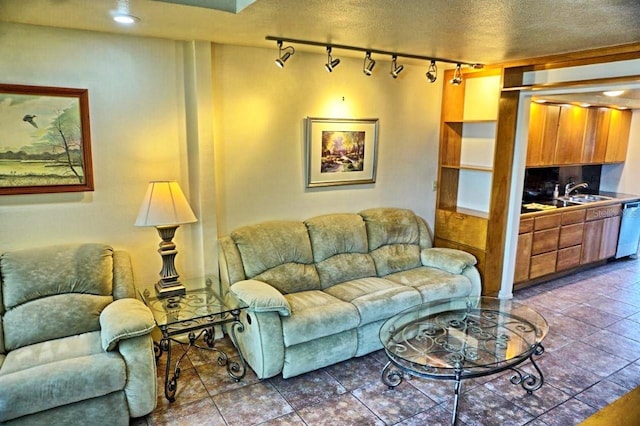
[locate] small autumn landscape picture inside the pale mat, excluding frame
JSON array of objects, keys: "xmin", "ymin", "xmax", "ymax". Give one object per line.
[{"xmin": 320, "ymin": 131, "xmax": 365, "ymax": 173}]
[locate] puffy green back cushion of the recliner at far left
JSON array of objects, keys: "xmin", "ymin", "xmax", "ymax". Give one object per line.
[{"xmin": 0, "ymin": 244, "xmax": 113, "ymax": 351}]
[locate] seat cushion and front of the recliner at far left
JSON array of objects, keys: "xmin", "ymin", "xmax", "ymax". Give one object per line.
[{"xmin": 0, "ymin": 332, "xmax": 127, "ymax": 422}]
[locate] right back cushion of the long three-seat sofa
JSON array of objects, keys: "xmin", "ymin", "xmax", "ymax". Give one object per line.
[{"xmin": 360, "ymin": 208, "xmax": 428, "ymax": 277}]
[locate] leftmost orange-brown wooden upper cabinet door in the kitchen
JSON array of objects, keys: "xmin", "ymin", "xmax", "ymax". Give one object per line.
[{"xmin": 527, "ymin": 102, "xmax": 560, "ymax": 167}]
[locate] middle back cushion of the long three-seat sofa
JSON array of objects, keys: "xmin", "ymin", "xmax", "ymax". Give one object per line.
[{"xmin": 305, "ymin": 214, "xmax": 376, "ymax": 289}]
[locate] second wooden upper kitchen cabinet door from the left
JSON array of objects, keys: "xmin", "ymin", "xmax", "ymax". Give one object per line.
[{"xmin": 554, "ymin": 106, "xmax": 588, "ymax": 164}]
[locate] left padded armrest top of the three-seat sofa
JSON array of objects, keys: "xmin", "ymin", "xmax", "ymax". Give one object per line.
[{"xmin": 229, "ymin": 280, "xmax": 291, "ymax": 317}]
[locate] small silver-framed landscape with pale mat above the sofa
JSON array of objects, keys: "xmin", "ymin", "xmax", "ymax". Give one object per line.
[{"xmin": 306, "ymin": 117, "xmax": 378, "ymax": 188}]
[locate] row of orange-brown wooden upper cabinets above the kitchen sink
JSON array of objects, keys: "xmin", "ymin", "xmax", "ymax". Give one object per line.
[{"xmin": 527, "ymin": 102, "xmax": 631, "ymax": 167}]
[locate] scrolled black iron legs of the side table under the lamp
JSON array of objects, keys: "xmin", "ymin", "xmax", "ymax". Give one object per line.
[{"xmin": 154, "ymin": 321, "xmax": 247, "ymax": 402}]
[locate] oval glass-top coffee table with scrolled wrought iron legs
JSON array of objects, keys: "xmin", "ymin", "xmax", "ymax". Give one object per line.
[{"xmin": 380, "ymin": 297, "xmax": 549, "ymax": 424}]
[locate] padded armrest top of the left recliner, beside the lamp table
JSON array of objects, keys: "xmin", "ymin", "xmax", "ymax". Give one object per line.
[{"xmin": 100, "ymin": 298, "xmax": 156, "ymax": 351}]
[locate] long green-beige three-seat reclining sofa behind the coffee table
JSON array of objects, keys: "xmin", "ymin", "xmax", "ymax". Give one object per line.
[{"xmin": 219, "ymin": 208, "xmax": 481, "ymax": 379}]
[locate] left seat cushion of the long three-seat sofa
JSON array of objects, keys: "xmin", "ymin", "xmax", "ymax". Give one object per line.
[{"xmin": 282, "ymin": 290, "xmax": 360, "ymax": 347}]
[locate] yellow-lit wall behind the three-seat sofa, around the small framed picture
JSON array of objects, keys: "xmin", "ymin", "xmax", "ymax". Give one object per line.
[{"xmin": 214, "ymin": 43, "xmax": 442, "ymax": 234}]
